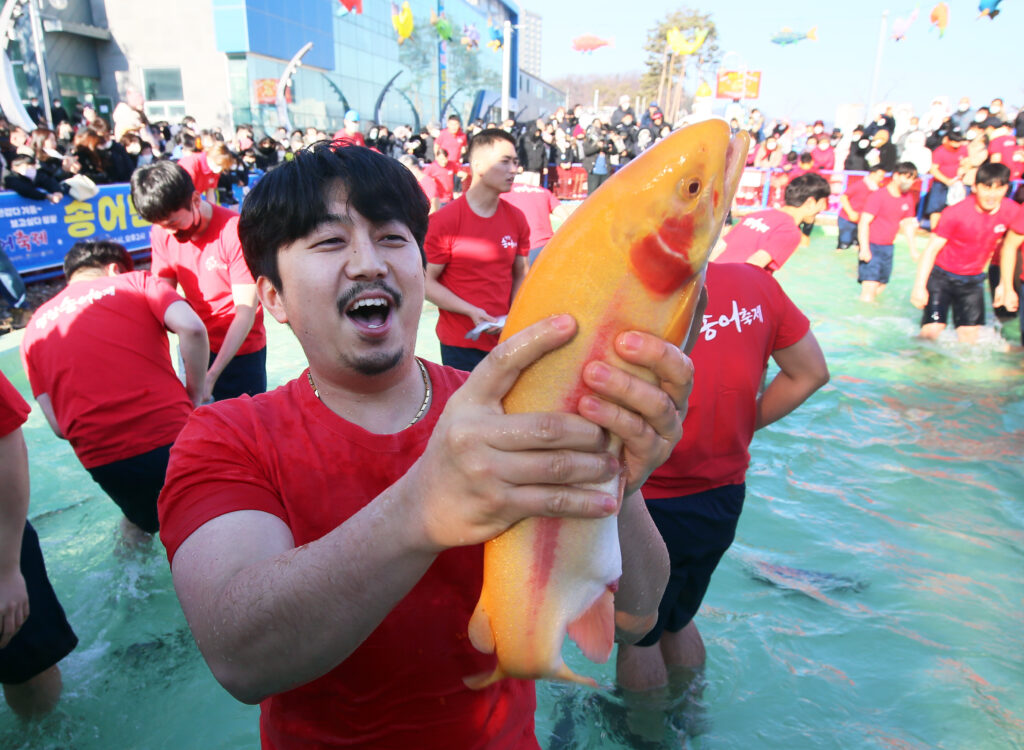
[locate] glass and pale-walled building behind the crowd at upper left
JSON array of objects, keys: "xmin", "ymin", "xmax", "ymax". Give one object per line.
[{"xmin": 11, "ymin": 0, "xmax": 519, "ymax": 131}]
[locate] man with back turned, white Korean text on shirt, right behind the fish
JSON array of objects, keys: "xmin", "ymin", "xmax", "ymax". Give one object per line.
[{"xmin": 616, "ymin": 262, "xmax": 828, "ymax": 691}]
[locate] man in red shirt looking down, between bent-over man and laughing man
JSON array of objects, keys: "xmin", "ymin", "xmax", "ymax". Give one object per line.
[{"xmin": 131, "ymin": 161, "xmax": 266, "ymax": 402}]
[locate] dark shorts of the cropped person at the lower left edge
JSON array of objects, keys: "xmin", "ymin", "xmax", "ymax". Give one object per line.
[{"xmin": 0, "ymin": 522, "xmax": 78, "ymax": 684}]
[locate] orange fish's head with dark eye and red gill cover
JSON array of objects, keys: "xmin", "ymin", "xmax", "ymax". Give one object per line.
[{"xmin": 614, "ymin": 120, "xmax": 750, "ymax": 295}]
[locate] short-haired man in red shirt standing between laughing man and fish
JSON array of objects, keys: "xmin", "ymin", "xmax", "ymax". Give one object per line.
[{"xmin": 424, "ymin": 128, "xmax": 529, "ymax": 371}]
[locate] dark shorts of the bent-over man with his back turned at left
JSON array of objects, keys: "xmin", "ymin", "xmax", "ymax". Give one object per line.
[{"xmin": 86, "ymin": 443, "xmax": 173, "ymax": 534}]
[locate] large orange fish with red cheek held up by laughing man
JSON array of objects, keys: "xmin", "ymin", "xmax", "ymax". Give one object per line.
[{"xmin": 466, "ymin": 120, "xmax": 750, "ymax": 688}]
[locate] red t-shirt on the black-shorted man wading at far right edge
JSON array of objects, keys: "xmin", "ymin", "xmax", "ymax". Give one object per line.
[{"xmin": 935, "ymin": 196, "xmax": 1018, "ymax": 276}]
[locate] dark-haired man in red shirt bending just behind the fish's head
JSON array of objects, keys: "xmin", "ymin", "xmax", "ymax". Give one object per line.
[{"xmin": 711, "ymin": 173, "xmax": 831, "ymax": 274}]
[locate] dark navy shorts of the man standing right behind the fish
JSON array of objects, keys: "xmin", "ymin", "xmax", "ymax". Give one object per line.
[{"xmin": 637, "ymin": 485, "xmax": 746, "ymax": 645}]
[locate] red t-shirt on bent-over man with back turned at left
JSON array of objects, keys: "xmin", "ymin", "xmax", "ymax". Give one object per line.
[{"xmin": 22, "ymin": 270, "xmax": 193, "ymax": 468}]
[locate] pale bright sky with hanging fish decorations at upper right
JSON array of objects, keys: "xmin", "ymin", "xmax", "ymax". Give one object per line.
[{"xmin": 520, "ymin": 0, "xmax": 1024, "ymax": 122}]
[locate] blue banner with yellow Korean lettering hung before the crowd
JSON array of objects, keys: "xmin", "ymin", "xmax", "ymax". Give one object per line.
[{"xmin": 0, "ymin": 182, "xmax": 150, "ymax": 275}]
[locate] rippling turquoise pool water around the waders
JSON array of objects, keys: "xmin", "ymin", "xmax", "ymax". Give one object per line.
[{"xmin": 0, "ymin": 230, "xmax": 1024, "ymax": 750}]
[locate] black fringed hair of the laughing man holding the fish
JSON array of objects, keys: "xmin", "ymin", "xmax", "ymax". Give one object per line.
[{"xmin": 239, "ymin": 140, "xmax": 430, "ymax": 291}]
